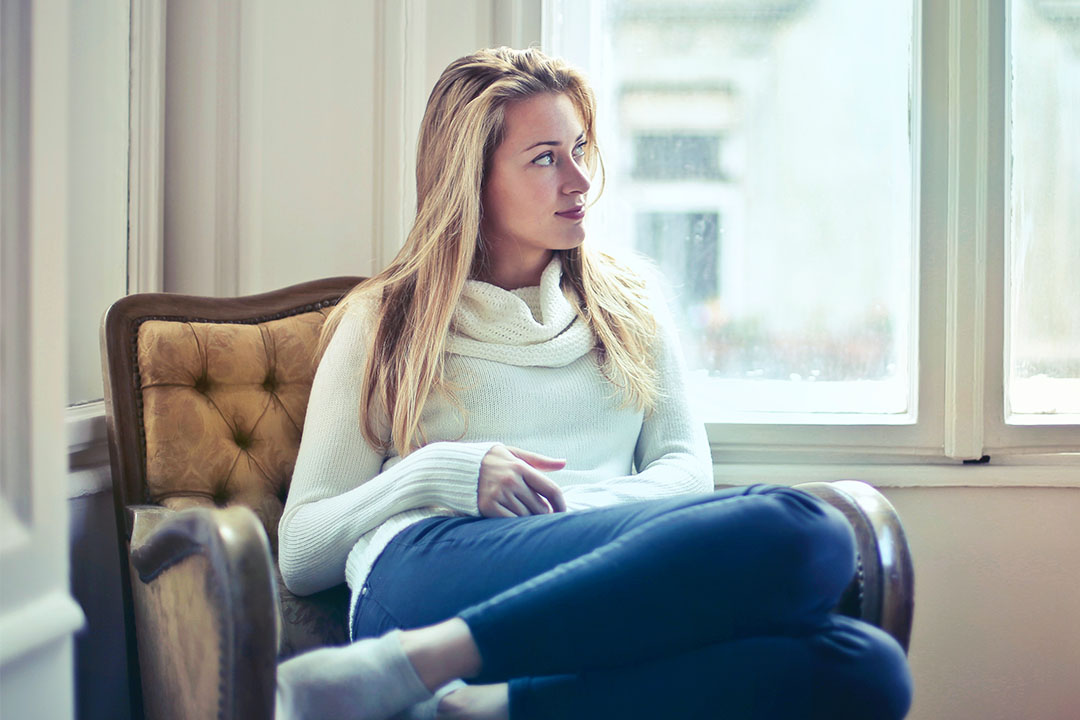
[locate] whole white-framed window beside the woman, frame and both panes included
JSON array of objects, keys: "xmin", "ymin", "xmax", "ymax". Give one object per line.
[{"xmin": 543, "ymin": 0, "xmax": 1080, "ymax": 460}]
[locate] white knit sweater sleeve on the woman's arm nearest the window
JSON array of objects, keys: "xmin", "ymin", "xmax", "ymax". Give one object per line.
[{"xmin": 564, "ymin": 278, "xmax": 713, "ymax": 511}]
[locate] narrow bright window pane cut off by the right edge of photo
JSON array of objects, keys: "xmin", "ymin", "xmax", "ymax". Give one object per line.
[{"xmin": 1007, "ymin": 0, "xmax": 1080, "ymax": 423}]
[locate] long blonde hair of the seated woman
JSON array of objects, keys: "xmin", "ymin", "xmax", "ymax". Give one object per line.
[{"xmin": 320, "ymin": 47, "xmax": 657, "ymax": 456}]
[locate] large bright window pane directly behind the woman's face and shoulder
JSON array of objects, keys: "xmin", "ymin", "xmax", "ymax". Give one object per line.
[{"xmin": 578, "ymin": 0, "xmax": 916, "ymax": 423}]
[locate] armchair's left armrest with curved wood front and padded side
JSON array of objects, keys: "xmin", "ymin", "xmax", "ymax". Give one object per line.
[{"xmin": 130, "ymin": 506, "xmax": 278, "ymax": 720}]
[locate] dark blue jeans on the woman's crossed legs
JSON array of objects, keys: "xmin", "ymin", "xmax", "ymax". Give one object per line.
[{"xmin": 353, "ymin": 486, "xmax": 912, "ymax": 720}]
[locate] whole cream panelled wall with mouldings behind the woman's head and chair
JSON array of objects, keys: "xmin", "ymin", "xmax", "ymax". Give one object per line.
[{"xmin": 164, "ymin": 0, "xmax": 524, "ymax": 295}]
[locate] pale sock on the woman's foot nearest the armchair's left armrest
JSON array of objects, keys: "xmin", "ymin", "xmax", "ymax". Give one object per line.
[{"xmin": 274, "ymin": 630, "xmax": 437, "ymax": 720}]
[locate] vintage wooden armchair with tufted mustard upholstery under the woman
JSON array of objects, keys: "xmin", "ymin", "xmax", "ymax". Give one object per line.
[{"xmin": 102, "ymin": 277, "xmax": 913, "ymax": 720}]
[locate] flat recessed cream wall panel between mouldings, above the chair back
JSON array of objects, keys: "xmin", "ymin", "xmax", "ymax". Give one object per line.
[{"xmin": 238, "ymin": 2, "xmax": 379, "ymax": 293}]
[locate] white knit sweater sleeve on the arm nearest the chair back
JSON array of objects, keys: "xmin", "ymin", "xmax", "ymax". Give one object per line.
[{"xmin": 278, "ymin": 313, "xmax": 492, "ymax": 595}]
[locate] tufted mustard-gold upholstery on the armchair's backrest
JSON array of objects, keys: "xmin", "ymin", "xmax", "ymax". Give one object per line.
[{"xmin": 137, "ymin": 310, "xmax": 327, "ymax": 551}]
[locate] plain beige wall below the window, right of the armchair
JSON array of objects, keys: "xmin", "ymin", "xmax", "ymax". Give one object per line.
[{"xmin": 886, "ymin": 487, "xmax": 1080, "ymax": 720}]
